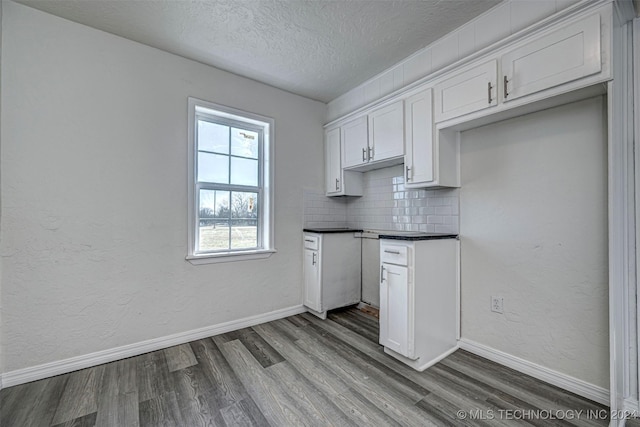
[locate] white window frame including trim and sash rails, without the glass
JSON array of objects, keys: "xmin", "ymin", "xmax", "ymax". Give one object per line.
[{"xmin": 186, "ymin": 97, "xmax": 276, "ymax": 265}]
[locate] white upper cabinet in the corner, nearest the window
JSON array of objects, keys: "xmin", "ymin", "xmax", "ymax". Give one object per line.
[{"xmin": 324, "ymin": 128, "xmax": 363, "ymax": 196}]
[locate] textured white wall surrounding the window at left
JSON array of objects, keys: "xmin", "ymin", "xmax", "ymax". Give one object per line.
[{"xmin": 0, "ymin": 2, "xmax": 326, "ymax": 372}]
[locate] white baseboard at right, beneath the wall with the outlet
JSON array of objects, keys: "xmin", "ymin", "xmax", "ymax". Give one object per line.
[{"xmin": 458, "ymin": 338, "xmax": 610, "ymax": 406}]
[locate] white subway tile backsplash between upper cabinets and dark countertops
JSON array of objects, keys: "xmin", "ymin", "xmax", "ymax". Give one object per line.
[{"xmin": 304, "ymin": 165, "xmax": 459, "ymax": 233}]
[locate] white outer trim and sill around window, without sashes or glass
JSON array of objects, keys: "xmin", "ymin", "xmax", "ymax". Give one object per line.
[{"xmin": 185, "ymin": 97, "xmax": 277, "ymax": 265}]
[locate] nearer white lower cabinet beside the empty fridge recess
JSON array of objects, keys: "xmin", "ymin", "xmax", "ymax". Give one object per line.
[{"xmin": 380, "ymin": 238, "xmax": 459, "ymax": 371}]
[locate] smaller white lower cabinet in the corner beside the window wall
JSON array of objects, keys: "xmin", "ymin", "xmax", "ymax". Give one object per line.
[{"xmin": 303, "ymin": 232, "xmax": 361, "ymax": 319}]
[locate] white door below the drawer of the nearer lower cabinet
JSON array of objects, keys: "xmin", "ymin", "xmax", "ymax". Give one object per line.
[{"xmin": 380, "ymin": 263, "xmax": 413, "ymax": 358}]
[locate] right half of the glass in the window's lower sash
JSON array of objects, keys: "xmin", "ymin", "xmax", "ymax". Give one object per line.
[{"xmin": 231, "ymin": 191, "xmax": 258, "ymax": 249}]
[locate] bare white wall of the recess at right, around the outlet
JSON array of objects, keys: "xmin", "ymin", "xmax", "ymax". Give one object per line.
[{"xmin": 460, "ymin": 98, "xmax": 609, "ymax": 389}]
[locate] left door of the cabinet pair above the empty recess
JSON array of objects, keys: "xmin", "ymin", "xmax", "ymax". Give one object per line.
[{"xmin": 434, "ymin": 60, "xmax": 498, "ymax": 123}]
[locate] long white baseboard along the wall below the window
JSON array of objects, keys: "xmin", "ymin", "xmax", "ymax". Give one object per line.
[{"xmin": 0, "ymin": 305, "xmax": 307, "ymax": 388}]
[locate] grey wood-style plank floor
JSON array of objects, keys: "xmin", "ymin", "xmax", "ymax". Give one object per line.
[{"xmin": 0, "ymin": 308, "xmax": 608, "ymax": 427}]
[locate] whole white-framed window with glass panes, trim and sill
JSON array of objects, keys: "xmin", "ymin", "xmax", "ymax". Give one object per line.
[{"xmin": 187, "ymin": 98, "xmax": 275, "ymax": 263}]
